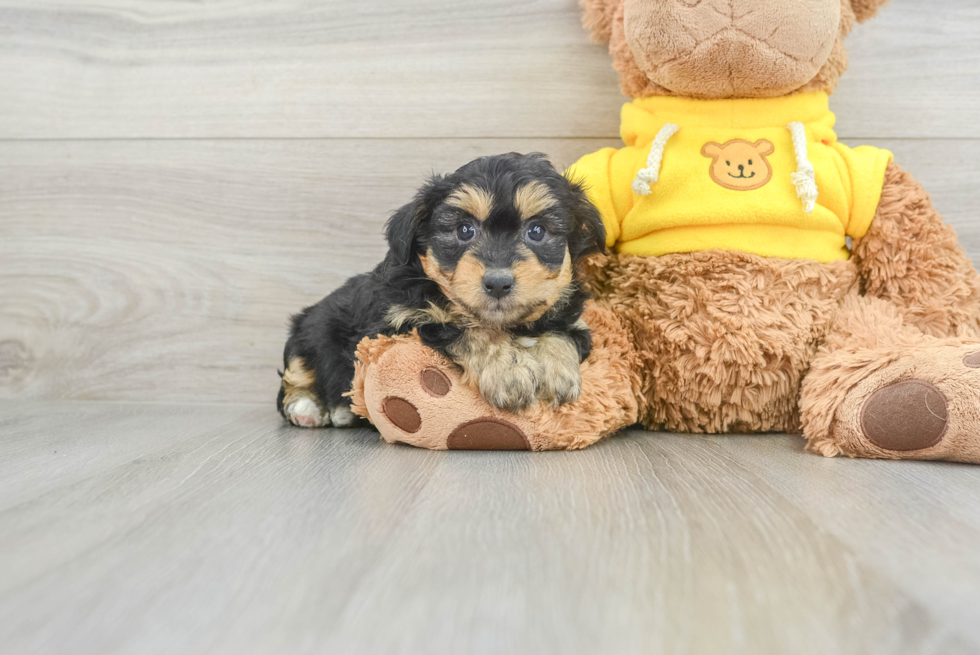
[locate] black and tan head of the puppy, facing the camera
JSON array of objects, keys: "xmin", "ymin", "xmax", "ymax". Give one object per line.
[{"xmin": 408, "ymin": 155, "xmax": 605, "ymax": 327}]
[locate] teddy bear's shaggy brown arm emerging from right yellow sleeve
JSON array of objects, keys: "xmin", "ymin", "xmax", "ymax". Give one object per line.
[{"xmin": 853, "ymin": 163, "xmax": 980, "ymax": 336}]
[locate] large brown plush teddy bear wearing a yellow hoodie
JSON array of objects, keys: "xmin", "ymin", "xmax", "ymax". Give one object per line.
[{"xmin": 351, "ymin": 0, "xmax": 980, "ymax": 463}]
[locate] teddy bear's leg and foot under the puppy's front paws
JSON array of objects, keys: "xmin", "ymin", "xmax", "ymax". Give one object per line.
[{"xmin": 351, "ymin": 304, "xmax": 639, "ymax": 450}]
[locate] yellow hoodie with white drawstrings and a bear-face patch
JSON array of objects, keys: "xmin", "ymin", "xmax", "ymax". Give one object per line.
[{"xmin": 566, "ymin": 93, "xmax": 892, "ymax": 262}]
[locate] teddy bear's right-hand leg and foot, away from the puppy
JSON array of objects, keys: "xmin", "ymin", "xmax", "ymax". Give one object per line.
[{"xmin": 800, "ymin": 295, "xmax": 980, "ymax": 463}]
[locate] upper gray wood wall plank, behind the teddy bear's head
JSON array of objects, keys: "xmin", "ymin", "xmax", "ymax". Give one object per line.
[{"xmin": 0, "ymin": 0, "xmax": 980, "ymax": 139}]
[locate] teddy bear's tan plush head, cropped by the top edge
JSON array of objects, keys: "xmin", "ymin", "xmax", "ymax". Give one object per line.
[{"xmin": 581, "ymin": 0, "xmax": 888, "ymax": 99}]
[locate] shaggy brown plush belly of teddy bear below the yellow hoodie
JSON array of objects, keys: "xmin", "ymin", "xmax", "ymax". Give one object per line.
[{"xmin": 580, "ymin": 251, "xmax": 856, "ymax": 432}]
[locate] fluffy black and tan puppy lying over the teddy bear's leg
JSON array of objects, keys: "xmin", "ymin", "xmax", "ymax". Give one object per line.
[{"xmin": 278, "ymin": 153, "xmax": 605, "ymax": 427}]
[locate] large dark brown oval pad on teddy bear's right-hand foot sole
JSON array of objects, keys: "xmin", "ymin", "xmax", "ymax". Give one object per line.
[{"xmin": 861, "ymin": 380, "xmax": 948, "ymax": 451}]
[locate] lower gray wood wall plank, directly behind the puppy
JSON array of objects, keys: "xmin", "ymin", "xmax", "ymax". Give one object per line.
[{"xmin": 0, "ymin": 139, "xmax": 980, "ymax": 403}]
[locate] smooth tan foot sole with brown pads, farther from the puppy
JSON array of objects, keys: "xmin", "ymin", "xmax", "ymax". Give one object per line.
[{"xmin": 831, "ymin": 342, "xmax": 980, "ymax": 463}]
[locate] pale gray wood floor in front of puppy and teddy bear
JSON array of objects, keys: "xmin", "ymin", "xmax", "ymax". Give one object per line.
[{"xmin": 0, "ymin": 403, "xmax": 980, "ymax": 655}]
